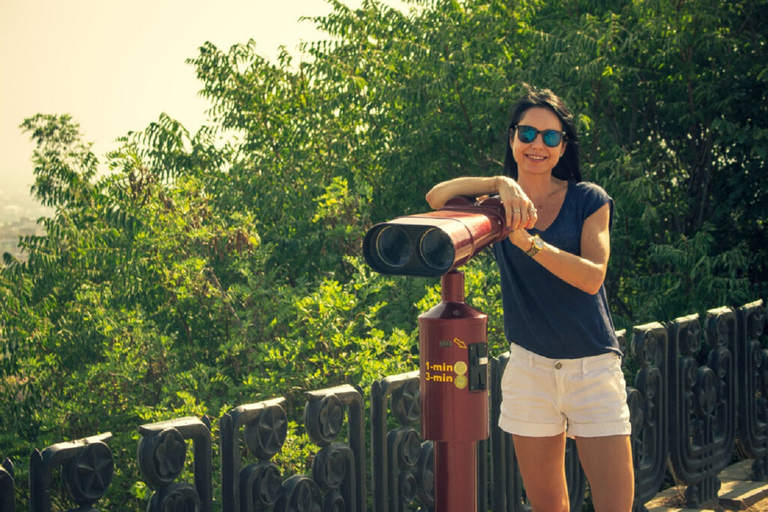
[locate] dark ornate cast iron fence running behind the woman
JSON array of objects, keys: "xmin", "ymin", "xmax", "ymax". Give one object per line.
[{"xmin": 0, "ymin": 301, "xmax": 768, "ymax": 512}]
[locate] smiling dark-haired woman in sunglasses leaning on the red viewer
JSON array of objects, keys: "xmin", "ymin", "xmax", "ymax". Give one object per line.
[{"xmin": 427, "ymin": 90, "xmax": 634, "ymax": 512}]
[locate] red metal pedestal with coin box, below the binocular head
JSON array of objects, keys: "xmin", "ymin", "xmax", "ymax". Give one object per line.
[{"xmin": 419, "ymin": 271, "xmax": 489, "ymax": 512}]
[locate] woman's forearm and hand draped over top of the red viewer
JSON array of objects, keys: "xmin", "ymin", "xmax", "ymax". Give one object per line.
[{"xmin": 427, "ymin": 176, "xmax": 538, "ymax": 229}]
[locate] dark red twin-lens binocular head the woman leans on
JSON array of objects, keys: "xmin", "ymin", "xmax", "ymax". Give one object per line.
[{"xmin": 363, "ymin": 196, "xmax": 507, "ymax": 277}]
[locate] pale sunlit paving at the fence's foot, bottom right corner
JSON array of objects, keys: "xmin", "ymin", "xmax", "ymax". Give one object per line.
[{"xmin": 646, "ymin": 460, "xmax": 768, "ymax": 512}]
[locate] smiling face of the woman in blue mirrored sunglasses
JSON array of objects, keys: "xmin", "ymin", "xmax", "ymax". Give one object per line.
[{"xmin": 510, "ymin": 107, "xmax": 566, "ymax": 177}]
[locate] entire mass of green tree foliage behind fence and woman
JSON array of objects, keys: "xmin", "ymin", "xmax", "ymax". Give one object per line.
[{"xmin": 0, "ymin": 0, "xmax": 768, "ymax": 510}]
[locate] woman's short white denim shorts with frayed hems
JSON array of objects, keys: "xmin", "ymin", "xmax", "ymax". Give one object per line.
[{"xmin": 499, "ymin": 344, "xmax": 632, "ymax": 437}]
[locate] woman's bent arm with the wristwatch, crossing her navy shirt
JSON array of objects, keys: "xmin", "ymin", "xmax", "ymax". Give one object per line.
[{"xmin": 509, "ymin": 204, "xmax": 611, "ymax": 295}]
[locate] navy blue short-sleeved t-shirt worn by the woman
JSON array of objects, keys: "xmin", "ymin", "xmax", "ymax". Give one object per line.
[{"xmin": 492, "ymin": 182, "xmax": 621, "ymax": 359}]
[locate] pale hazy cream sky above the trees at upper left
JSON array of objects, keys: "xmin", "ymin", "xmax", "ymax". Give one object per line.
[{"xmin": 0, "ymin": 0, "xmax": 390, "ymax": 189}]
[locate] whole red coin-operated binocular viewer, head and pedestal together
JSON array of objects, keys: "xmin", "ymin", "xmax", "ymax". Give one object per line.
[{"xmin": 363, "ymin": 197, "xmax": 508, "ymax": 512}]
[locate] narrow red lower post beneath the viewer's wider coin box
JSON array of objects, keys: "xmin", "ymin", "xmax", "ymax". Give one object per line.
[{"xmin": 434, "ymin": 441, "xmax": 477, "ymax": 512}]
